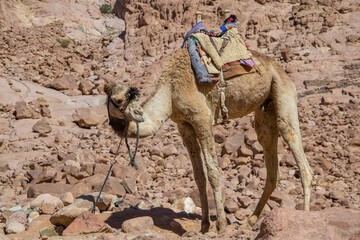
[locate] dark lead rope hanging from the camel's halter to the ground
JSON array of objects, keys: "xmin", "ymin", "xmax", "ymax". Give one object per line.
[{"xmin": 91, "ymin": 123, "xmax": 139, "ymax": 213}]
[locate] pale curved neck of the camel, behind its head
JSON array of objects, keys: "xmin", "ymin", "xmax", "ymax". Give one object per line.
[{"xmin": 128, "ymin": 82, "xmax": 172, "ymax": 137}]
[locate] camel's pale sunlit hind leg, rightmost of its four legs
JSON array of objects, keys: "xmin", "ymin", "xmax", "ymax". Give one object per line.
[{"xmin": 273, "ymin": 72, "xmax": 313, "ymax": 211}]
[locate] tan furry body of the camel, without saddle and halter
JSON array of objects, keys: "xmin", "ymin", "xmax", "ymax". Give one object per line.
[{"xmin": 105, "ymin": 50, "xmax": 313, "ymax": 233}]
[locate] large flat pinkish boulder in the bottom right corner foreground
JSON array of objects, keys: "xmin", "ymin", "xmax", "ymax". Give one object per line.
[{"xmin": 256, "ymin": 208, "xmax": 360, "ymax": 240}]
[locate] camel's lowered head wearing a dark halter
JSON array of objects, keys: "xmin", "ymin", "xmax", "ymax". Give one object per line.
[{"xmin": 104, "ymin": 84, "xmax": 144, "ymax": 127}]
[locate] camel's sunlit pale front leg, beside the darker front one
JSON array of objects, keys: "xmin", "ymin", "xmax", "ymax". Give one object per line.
[{"xmin": 194, "ymin": 117, "xmax": 227, "ymax": 233}]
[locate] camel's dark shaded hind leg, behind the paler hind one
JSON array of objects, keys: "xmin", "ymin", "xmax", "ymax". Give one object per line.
[{"xmin": 247, "ymin": 102, "xmax": 280, "ymax": 227}]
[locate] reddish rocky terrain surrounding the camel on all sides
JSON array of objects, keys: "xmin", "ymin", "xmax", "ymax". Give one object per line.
[{"xmin": 0, "ymin": 0, "xmax": 360, "ymax": 240}]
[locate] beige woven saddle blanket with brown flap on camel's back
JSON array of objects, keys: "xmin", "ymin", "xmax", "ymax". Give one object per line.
[{"xmin": 191, "ymin": 28, "xmax": 255, "ymax": 80}]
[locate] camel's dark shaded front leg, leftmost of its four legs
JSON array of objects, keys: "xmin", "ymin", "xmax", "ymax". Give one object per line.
[{"xmin": 178, "ymin": 122, "xmax": 210, "ymax": 233}]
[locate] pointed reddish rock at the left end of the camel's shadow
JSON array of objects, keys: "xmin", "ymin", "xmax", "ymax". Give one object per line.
[{"xmin": 62, "ymin": 212, "xmax": 114, "ymax": 236}]
